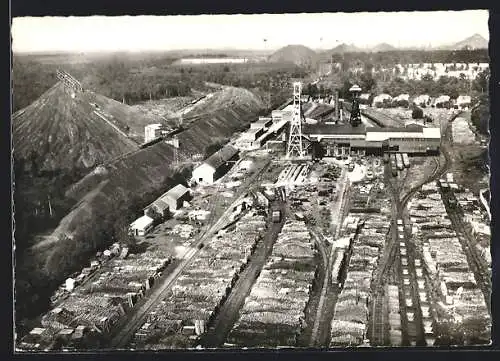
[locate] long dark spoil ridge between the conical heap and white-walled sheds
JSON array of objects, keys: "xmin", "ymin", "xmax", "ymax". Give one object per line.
[{"xmin": 35, "ymin": 88, "xmax": 263, "ymax": 252}]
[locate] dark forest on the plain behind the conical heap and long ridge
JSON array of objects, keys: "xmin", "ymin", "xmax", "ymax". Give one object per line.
[{"xmin": 13, "ymin": 55, "xmax": 307, "ymax": 112}]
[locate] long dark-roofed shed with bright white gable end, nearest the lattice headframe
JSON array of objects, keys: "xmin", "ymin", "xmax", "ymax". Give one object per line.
[{"xmin": 193, "ymin": 145, "xmax": 239, "ymax": 184}]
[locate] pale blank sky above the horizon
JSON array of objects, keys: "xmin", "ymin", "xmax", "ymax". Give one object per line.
[{"xmin": 12, "ymin": 10, "xmax": 489, "ymax": 52}]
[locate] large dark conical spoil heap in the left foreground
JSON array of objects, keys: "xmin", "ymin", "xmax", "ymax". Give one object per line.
[{"xmin": 12, "ymin": 82, "xmax": 141, "ymax": 169}]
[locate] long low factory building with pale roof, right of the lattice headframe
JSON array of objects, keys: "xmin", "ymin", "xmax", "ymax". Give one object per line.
[{"xmin": 303, "ymin": 123, "xmax": 441, "ymax": 157}]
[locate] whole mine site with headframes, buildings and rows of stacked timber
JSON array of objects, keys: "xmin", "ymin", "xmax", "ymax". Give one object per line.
[{"xmin": 19, "ymin": 76, "xmax": 491, "ymax": 350}]
